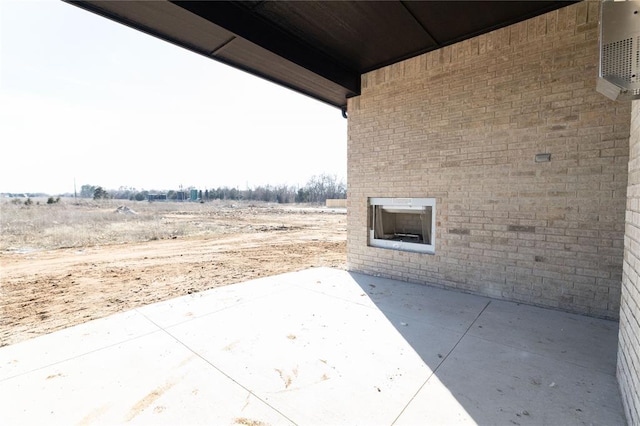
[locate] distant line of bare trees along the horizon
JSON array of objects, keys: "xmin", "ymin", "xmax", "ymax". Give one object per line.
[{"xmin": 80, "ymin": 174, "xmax": 347, "ymax": 203}]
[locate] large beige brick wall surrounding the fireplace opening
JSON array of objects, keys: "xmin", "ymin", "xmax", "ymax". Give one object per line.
[{"xmin": 347, "ymin": 2, "xmax": 630, "ymax": 318}]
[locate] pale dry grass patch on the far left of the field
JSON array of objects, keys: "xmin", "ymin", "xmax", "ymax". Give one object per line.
[{"xmin": 0, "ymin": 199, "xmax": 242, "ymax": 251}]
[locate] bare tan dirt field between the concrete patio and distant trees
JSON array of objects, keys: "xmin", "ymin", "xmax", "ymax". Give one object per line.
[{"xmin": 0, "ymin": 203, "xmax": 346, "ymax": 346}]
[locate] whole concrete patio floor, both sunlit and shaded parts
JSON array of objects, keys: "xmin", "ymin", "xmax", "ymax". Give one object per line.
[{"xmin": 0, "ymin": 268, "xmax": 625, "ymax": 425}]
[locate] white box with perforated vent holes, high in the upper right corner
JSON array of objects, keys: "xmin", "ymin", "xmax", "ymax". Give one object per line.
[{"xmin": 596, "ymin": 0, "xmax": 640, "ymax": 100}]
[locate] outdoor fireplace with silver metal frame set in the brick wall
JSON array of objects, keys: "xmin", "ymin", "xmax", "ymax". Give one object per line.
[{"xmin": 368, "ymin": 198, "xmax": 436, "ymax": 254}]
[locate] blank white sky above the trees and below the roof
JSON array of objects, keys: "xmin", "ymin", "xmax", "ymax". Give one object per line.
[{"xmin": 0, "ymin": 0, "xmax": 347, "ymax": 194}]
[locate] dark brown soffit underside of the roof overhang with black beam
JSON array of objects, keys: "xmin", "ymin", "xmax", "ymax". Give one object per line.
[{"xmin": 69, "ymin": 0, "xmax": 575, "ymax": 107}]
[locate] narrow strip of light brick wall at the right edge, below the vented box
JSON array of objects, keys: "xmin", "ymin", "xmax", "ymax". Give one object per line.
[{"xmin": 618, "ymin": 101, "xmax": 640, "ymax": 425}]
